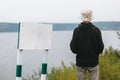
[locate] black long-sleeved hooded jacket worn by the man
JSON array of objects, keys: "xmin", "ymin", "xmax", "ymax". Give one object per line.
[{"xmin": 70, "ymin": 22, "xmax": 104, "ymax": 67}]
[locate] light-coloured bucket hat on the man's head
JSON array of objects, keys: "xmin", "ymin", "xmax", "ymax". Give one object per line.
[{"xmin": 81, "ymin": 10, "xmax": 93, "ymax": 22}]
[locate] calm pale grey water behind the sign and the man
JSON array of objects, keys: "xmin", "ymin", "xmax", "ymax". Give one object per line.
[{"xmin": 0, "ymin": 31, "xmax": 120, "ymax": 80}]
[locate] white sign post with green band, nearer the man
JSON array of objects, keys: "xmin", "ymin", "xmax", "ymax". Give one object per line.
[{"xmin": 41, "ymin": 49, "xmax": 48, "ymax": 80}]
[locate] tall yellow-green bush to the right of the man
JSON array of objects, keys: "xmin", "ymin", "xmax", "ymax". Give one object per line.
[{"xmin": 99, "ymin": 47, "xmax": 120, "ymax": 80}]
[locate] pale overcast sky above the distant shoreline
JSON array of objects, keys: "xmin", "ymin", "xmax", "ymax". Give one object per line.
[{"xmin": 0, "ymin": 0, "xmax": 120, "ymax": 23}]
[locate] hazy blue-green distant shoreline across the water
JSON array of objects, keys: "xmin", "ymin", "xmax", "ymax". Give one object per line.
[{"xmin": 0, "ymin": 21, "xmax": 120, "ymax": 32}]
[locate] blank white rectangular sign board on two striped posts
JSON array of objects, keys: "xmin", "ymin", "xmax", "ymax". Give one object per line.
[{"xmin": 18, "ymin": 22, "xmax": 52, "ymax": 50}]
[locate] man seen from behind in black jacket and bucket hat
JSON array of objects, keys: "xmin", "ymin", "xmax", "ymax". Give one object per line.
[{"xmin": 70, "ymin": 10, "xmax": 104, "ymax": 80}]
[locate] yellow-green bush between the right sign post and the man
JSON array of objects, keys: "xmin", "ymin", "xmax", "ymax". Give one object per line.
[{"xmin": 48, "ymin": 61, "xmax": 76, "ymax": 80}]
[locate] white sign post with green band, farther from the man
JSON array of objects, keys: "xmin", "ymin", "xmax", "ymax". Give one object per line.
[{"xmin": 16, "ymin": 49, "xmax": 23, "ymax": 80}]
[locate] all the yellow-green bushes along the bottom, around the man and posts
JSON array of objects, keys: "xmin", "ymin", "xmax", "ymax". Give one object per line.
[{"xmin": 23, "ymin": 47, "xmax": 120, "ymax": 80}]
